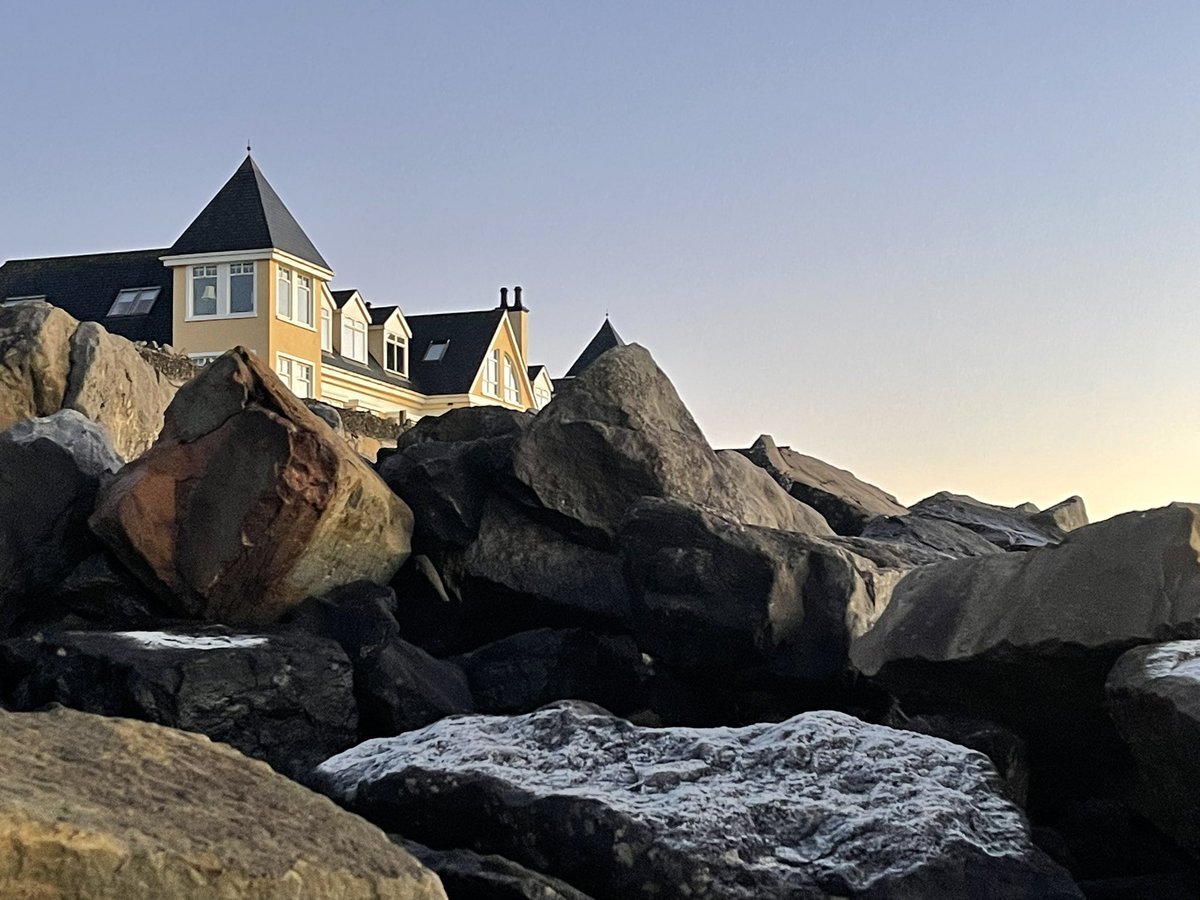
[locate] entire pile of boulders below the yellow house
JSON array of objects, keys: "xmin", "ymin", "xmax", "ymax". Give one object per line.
[{"xmin": 0, "ymin": 321, "xmax": 1200, "ymax": 900}]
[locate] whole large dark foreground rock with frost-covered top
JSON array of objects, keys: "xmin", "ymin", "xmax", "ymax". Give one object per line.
[{"xmin": 318, "ymin": 703, "xmax": 1079, "ymax": 900}]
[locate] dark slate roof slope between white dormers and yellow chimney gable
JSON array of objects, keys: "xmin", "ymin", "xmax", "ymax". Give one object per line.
[{"xmin": 404, "ymin": 308, "xmax": 504, "ymax": 394}]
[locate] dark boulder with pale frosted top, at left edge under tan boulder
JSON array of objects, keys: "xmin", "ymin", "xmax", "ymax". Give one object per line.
[{"xmin": 0, "ymin": 409, "xmax": 121, "ymax": 632}]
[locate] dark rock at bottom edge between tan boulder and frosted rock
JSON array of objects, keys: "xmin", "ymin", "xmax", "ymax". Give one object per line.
[{"xmin": 391, "ymin": 835, "xmax": 592, "ymax": 900}]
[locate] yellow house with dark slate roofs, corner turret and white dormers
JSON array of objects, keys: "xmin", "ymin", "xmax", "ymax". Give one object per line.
[{"xmin": 0, "ymin": 155, "xmax": 553, "ymax": 421}]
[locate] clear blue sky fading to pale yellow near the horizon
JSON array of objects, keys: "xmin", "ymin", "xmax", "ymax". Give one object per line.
[{"xmin": 0, "ymin": 0, "xmax": 1200, "ymax": 518}]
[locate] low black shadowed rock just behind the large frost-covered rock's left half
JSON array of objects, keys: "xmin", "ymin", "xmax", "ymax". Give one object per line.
[{"xmin": 455, "ymin": 628, "xmax": 649, "ymax": 715}]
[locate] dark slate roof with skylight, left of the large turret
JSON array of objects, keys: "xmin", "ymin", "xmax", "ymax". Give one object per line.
[{"xmin": 0, "ymin": 250, "xmax": 172, "ymax": 343}]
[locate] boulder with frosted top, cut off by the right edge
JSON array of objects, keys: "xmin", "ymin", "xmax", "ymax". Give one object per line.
[{"xmin": 1106, "ymin": 641, "xmax": 1200, "ymax": 856}]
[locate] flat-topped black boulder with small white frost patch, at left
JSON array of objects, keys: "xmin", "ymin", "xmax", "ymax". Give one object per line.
[{"xmin": 0, "ymin": 629, "xmax": 359, "ymax": 779}]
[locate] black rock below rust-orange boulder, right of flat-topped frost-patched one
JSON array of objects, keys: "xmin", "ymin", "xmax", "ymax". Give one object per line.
[{"xmin": 288, "ymin": 582, "xmax": 475, "ymax": 737}]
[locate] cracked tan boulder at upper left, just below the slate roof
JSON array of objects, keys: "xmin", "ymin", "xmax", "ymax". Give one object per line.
[{"xmin": 0, "ymin": 302, "xmax": 175, "ymax": 458}]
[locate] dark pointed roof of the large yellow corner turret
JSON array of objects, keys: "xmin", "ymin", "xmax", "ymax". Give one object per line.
[{"xmin": 168, "ymin": 155, "xmax": 330, "ymax": 269}]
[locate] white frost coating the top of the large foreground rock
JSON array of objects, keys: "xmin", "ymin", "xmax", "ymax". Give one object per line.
[{"xmin": 319, "ymin": 706, "xmax": 1033, "ymax": 896}]
